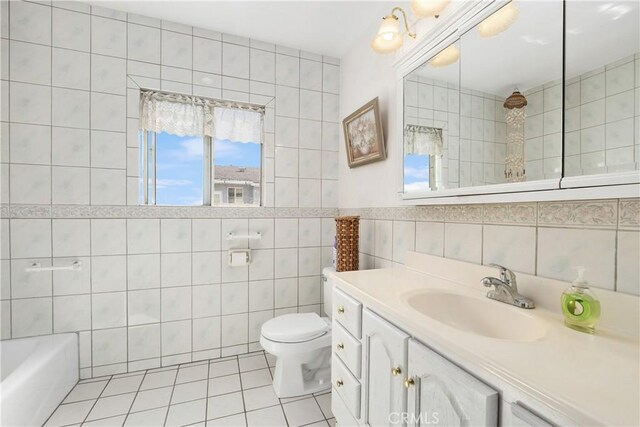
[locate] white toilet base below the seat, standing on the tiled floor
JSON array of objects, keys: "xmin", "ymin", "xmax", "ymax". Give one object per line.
[{"xmin": 273, "ymin": 347, "xmax": 331, "ymax": 399}]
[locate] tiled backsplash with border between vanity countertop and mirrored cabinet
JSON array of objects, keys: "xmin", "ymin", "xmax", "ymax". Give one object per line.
[{"xmin": 352, "ymin": 199, "xmax": 640, "ymax": 295}]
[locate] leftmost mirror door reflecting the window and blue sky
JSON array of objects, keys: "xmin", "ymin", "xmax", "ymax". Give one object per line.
[{"xmin": 403, "ymin": 43, "xmax": 460, "ymax": 193}]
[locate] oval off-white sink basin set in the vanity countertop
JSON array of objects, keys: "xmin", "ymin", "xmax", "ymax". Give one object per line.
[{"xmin": 406, "ymin": 291, "xmax": 546, "ymax": 341}]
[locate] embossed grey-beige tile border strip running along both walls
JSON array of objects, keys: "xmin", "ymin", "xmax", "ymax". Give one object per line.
[{"xmin": 6, "ymin": 198, "xmax": 640, "ymax": 229}]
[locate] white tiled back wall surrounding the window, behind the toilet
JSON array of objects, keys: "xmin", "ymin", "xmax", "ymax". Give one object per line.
[{"xmin": 0, "ymin": 1, "xmax": 339, "ymax": 377}]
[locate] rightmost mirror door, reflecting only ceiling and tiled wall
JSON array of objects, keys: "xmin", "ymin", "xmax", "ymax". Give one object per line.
[{"xmin": 565, "ymin": 0, "xmax": 640, "ymax": 176}]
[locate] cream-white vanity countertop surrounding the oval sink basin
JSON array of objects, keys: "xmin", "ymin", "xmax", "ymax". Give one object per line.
[{"xmin": 335, "ymin": 267, "xmax": 640, "ymax": 426}]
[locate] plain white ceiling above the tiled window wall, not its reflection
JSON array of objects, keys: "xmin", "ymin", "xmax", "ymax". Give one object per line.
[{"xmin": 90, "ymin": 0, "xmax": 402, "ymax": 58}]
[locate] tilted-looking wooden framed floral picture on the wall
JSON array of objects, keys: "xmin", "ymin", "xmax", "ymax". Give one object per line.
[{"xmin": 342, "ymin": 98, "xmax": 387, "ymax": 168}]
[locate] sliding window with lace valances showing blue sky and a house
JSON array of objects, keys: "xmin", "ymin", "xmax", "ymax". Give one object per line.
[{"xmin": 140, "ymin": 91, "xmax": 264, "ymax": 206}]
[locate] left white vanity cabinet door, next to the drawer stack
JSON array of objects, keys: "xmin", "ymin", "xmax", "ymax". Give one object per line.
[{"xmin": 362, "ymin": 310, "xmax": 409, "ymax": 426}]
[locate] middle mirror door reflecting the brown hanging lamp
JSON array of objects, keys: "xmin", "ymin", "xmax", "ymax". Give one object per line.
[{"xmin": 460, "ymin": 0, "xmax": 564, "ymax": 187}]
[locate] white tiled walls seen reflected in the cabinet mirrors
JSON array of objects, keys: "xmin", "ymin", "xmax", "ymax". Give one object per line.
[{"xmin": 405, "ymin": 54, "xmax": 640, "ymax": 187}]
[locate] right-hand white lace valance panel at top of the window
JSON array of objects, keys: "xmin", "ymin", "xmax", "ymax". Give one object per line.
[{"xmin": 214, "ymin": 107, "xmax": 264, "ymax": 144}]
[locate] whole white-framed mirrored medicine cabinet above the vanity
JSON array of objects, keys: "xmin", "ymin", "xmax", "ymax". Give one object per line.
[{"xmin": 398, "ymin": 0, "xmax": 640, "ymax": 201}]
